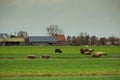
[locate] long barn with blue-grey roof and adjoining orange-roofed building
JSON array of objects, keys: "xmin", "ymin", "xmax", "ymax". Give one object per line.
[{"xmin": 28, "ymin": 35, "xmax": 66, "ymax": 45}]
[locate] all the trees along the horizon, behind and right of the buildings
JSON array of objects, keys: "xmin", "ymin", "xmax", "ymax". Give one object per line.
[{"xmin": 11, "ymin": 25, "xmax": 120, "ymax": 46}]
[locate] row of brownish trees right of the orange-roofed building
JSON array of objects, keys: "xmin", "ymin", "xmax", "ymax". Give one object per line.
[{"xmin": 67, "ymin": 32, "xmax": 120, "ymax": 46}]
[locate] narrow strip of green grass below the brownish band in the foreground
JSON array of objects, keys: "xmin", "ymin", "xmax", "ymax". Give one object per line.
[{"xmin": 0, "ymin": 75, "xmax": 120, "ymax": 80}]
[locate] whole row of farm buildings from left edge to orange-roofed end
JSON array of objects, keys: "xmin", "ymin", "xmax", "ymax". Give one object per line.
[{"xmin": 0, "ymin": 33, "xmax": 66, "ymax": 46}]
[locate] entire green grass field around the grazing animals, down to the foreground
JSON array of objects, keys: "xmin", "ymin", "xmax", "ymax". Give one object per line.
[{"xmin": 0, "ymin": 46, "xmax": 120, "ymax": 80}]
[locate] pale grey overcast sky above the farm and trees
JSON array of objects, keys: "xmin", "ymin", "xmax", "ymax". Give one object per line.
[{"xmin": 0, "ymin": 0, "xmax": 120, "ymax": 37}]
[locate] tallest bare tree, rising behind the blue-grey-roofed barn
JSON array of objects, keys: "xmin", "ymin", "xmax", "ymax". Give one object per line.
[{"xmin": 47, "ymin": 25, "xmax": 63, "ymax": 36}]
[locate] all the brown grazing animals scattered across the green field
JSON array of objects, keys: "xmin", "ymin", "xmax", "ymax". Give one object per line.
[{"xmin": 27, "ymin": 48, "xmax": 107, "ymax": 59}]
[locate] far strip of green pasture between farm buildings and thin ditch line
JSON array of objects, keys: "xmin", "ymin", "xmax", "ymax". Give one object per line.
[{"xmin": 0, "ymin": 46, "xmax": 120, "ymax": 59}]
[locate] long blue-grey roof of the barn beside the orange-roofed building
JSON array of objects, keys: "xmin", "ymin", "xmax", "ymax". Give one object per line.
[{"xmin": 28, "ymin": 36, "xmax": 57, "ymax": 43}]
